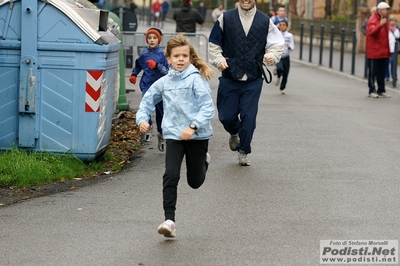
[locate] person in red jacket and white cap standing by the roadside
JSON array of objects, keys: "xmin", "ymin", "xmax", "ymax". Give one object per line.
[{"xmin": 366, "ymin": 2, "xmax": 390, "ymax": 98}]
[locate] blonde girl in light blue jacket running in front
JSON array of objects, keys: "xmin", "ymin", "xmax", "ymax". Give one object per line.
[{"xmin": 136, "ymin": 33, "xmax": 215, "ymax": 237}]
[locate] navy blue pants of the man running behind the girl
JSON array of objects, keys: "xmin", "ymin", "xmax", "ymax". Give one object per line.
[{"xmin": 217, "ymin": 77, "xmax": 263, "ymax": 153}]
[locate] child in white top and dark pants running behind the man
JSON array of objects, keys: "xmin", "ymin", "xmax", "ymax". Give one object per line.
[{"xmin": 275, "ymin": 21, "xmax": 294, "ymax": 94}]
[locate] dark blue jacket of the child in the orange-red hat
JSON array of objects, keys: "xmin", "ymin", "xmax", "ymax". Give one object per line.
[{"xmin": 132, "ymin": 46, "xmax": 168, "ymax": 92}]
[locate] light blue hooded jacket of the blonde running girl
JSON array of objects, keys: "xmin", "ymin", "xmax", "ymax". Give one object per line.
[{"xmin": 136, "ymin": 65, "xmax": 215, "ymax": 140}]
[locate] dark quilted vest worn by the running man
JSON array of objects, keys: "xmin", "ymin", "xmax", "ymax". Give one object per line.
[{"xmin": 222, "ymin": 9, "xmax": 270, "ymax": 81}]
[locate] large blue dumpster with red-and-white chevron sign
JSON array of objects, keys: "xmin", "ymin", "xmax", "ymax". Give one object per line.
[{"xmin": 0, "ymin": 0, "xmax": 121, "ymax": 161}]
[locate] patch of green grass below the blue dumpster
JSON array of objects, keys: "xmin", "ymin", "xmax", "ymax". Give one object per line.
[{"xmin": 0, "ymin": 149, "xmax": 113, "ymax": 188}]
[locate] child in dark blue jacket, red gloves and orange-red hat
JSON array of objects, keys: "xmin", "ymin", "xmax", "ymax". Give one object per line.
[{"xmin": 129, "ymin": 28, "xmax": 168, "ymax": 151}]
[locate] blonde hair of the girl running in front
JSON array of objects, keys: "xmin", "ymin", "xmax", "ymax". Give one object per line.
[{"xmin": 165, "ymin": 33, "xmax": 214, "ymax": 80}]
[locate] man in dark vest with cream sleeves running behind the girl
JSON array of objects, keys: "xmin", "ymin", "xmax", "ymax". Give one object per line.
[{"xmin": 208, "ymin": 0, "xmax": 284, "ymax": 166}]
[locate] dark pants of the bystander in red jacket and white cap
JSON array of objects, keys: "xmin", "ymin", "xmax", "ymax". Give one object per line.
[{"xmin": 368, "ymin": 58, "xmax": 386, "ymax": 94}]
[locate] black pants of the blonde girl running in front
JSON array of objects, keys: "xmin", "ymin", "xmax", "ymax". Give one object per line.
[{"xmin": 163, "ymin": 139, "xmax": 208, "ymax": 221}]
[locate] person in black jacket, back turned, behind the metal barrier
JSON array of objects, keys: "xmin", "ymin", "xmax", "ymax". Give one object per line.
[{"xmin": 173, "ymin": 0, "xmax": 204, "ymax": 33}]
